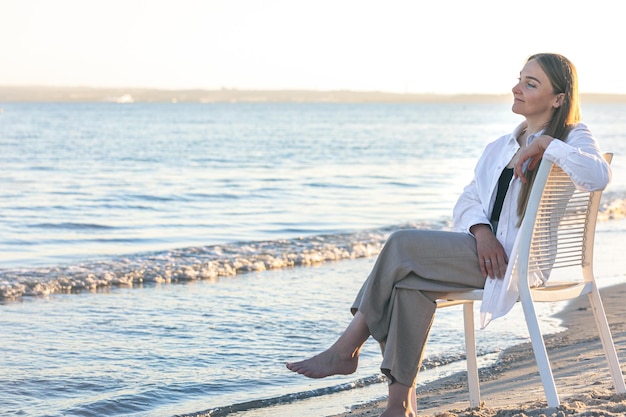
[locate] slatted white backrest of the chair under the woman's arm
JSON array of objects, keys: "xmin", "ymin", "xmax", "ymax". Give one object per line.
[{"xmin": 515, "ymin": 154, "xmax": 613, "ymax": 286}]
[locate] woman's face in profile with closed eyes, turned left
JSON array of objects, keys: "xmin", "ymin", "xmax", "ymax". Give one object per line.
[{"xmin": 512, "ymin": 59, "xmax": 564, "ymax": 126}]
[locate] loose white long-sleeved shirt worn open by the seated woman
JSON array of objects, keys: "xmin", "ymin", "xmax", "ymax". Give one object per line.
[{"xmin": 453, "ymin": 123, "xmax": 611, "ymax": 328}]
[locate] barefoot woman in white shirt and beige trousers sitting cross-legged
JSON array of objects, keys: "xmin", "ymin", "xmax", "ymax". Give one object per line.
[{"xmin": 287, "ymin": 54, "xmax": 611, "ymax": 417}]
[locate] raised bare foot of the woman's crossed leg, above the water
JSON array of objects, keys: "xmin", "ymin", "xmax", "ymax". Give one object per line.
[{"xmin": 287, "ymin": 347, "xmax": 359, "ymax": 378}]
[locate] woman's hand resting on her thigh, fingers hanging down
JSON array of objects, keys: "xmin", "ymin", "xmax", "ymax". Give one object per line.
[{"xmin": 470, "ymin": 224, "xmax": 509, "ymax": 278}]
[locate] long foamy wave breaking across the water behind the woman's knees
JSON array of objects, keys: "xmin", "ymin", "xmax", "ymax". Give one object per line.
[{"xmin": 0, "ymin": 194, "xmax": 626, "ymax": 300}]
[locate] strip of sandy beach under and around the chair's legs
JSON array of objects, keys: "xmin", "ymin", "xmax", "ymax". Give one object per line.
[{"xmin": 326, "ymin": 276, "xmax": 626, "ymax": 417}]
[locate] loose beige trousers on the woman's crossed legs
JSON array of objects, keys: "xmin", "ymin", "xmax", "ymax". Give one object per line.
[{"xmin": 352, "ymin": 230, "xmax": 485, "ymax": 386}]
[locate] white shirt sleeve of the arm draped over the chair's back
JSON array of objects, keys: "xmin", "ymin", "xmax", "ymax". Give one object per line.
[{"xmin": 543, "ymin": 123, "xmax": 611, "ymax": 191}]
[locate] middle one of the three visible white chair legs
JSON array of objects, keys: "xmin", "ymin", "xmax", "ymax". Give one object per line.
[{"xmin": 522, "ymin": 300, "xmax": 560, "ymax": 407}]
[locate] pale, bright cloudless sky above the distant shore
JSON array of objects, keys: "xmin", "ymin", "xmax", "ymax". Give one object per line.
[{"xmin": 0, "ymin": 0, "xmax": 626, "ymax": 94}]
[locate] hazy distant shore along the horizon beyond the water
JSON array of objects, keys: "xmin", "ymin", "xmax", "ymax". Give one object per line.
[{"xmin": 0, "ymin": 86, "xmax": 626, "ymax": 103}]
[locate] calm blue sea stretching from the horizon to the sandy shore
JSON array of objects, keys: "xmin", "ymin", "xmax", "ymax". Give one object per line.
[{"xmin": 0, "ymin": 102, "xmax": 626, "ymax": 417}]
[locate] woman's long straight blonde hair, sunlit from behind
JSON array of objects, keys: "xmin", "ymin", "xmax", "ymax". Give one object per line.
[{"xmin": 517, "ymin": 53, "xmax": 581, "ymax": 226}]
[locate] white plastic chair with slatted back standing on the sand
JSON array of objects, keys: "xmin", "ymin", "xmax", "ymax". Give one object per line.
[{"xmin": 438, "ymin": 154, "xmax": 626, "ymax": 407}]
